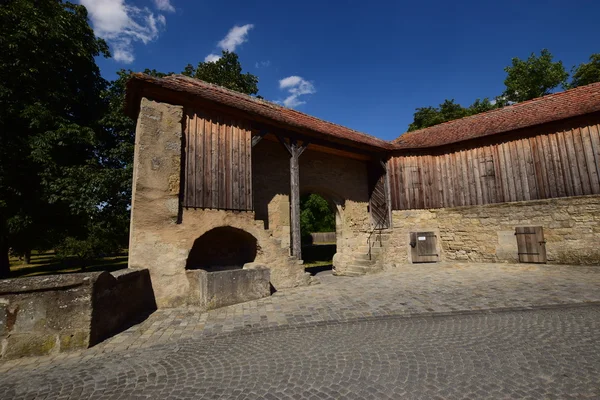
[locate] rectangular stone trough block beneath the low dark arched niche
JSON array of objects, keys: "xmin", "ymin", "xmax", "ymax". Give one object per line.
[{"xmin": 186, "ymin": 268, "xmax": 271, "ymax": 310}]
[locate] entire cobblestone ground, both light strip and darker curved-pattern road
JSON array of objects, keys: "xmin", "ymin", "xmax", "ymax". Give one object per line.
[{"xmin": 0, "ymin": 264, "xmax": 600, "ymax": 399}]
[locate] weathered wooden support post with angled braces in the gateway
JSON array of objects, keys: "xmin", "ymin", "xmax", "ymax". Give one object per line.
[{"xmin": 277, "ymin": 136, "xmax": 309, "ymax": 260}]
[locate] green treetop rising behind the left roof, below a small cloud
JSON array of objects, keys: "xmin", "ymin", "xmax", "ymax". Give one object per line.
[{"xmin": 182, "ymin": 50, "xmax": 258, "ymax": 95}]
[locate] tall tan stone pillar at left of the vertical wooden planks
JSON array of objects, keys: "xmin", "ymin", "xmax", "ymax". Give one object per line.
[{"xmin": 129, "ymin": 98, "xmax": 189, "ymax": 307}]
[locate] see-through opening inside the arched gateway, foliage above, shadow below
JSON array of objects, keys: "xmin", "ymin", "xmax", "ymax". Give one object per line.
[{"xmin": 300, "ymin": 193, "xmax": 337, "ymax": 275}]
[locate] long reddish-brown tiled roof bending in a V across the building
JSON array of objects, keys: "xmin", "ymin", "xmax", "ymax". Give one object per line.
[{"xmin": 127, "ymin": 73, "xmax": 600, "ymax": 151}]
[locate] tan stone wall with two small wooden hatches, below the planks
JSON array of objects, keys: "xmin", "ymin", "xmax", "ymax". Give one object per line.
[{"xmin": 383, "ymin": 196, "xmax": 600, "ymax": 265}]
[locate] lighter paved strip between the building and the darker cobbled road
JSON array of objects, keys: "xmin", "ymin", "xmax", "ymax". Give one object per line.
[{"xmin": 0, "ymin": 264, "xmax": 600, "ymax": 372}]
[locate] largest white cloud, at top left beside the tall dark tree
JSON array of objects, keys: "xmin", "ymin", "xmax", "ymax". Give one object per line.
[{"xmin": 80, "ymin": 0, "xmax": 170, "ymax": 63}]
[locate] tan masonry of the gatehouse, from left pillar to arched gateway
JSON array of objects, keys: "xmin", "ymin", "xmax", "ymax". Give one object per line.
[{"xmin": 129, "ymin": 98, "xmax": 378, "ymax": 307}]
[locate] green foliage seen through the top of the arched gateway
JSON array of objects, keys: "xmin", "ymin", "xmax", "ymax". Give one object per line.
[{"xmin": 300, "ymin": 193, "xmax": 335, "ymax": 241}]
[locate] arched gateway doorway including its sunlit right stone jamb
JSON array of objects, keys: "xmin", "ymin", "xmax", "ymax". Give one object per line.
[{"xmin": 300, "ymin": 187, "xmax": 343, "ymax": 275}]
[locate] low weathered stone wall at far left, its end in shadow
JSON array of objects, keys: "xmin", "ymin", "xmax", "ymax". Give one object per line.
[{"xmin": 0, "ymin": 270, "xmax": 156, "ymax": 359}]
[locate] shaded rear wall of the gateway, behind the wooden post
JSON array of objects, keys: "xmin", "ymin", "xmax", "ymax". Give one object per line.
[{"xmin": 253, "ymin": 140, "xmax": 371, "ymax": 274}]
